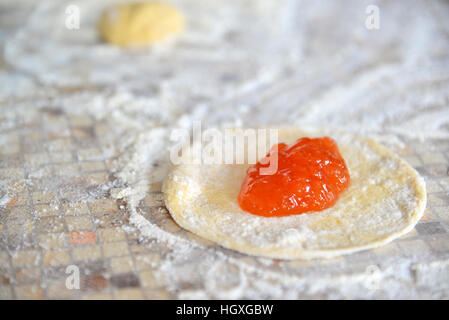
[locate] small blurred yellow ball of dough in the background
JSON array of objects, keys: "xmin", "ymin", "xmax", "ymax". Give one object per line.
[{"xmin": 98, "ymin": 2, "xmax": 184, "ymax": 47}]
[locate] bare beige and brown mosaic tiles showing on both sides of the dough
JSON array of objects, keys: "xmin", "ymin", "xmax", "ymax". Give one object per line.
[{"xmin": 0, "ymin": 109, "xmax": 449, "ymax": 299}]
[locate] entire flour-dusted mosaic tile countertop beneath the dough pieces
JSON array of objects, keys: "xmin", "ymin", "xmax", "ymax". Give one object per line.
[{"xmin": 0, "ymin": 0, "xmax": 449, "ymax": 299}]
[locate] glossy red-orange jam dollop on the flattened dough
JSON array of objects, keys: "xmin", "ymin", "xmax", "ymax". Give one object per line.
[{"xmin": 238, "ymin": 137, "xmax": 349, "ymax": 217}]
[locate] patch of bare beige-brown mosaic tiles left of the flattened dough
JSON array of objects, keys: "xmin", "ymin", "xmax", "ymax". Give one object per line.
[{"xmin": 0, "ymin": 110, "xmax": 175, "ymax": 299}]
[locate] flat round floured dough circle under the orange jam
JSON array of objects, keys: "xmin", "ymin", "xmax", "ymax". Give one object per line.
[{"xmin": 163, "ymin": 128, "xmax": 426, "ymax": 259}]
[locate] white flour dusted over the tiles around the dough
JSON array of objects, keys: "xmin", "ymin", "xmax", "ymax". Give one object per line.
[{"xmin": 0, "ymin": 0, "xmax": 449, "ymax": 299}]
